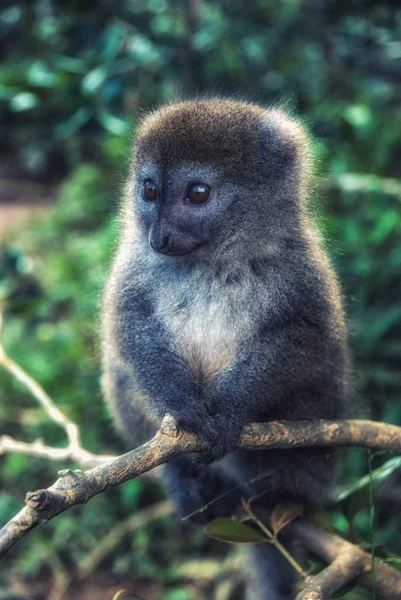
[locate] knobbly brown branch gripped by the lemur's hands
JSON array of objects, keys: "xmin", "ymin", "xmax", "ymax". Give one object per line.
[{"xmin": 0, "ymin": 415, "xmax": 401, "ymax": 557}]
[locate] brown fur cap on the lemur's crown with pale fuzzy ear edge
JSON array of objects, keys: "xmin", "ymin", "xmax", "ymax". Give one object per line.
[{"xmin": 137, "ymin": 99, "xmax": 309, "ymax": 188}]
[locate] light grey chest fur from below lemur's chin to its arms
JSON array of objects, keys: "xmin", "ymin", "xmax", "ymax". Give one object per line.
[{"xmin": 154, "ymin": 270, "xmax": 268, "ymax": 383}]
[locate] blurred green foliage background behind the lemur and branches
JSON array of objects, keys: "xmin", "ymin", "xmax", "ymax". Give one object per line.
[{"xmin": 0, "ymin": 0, "xmax": 401, "ymax": 600}]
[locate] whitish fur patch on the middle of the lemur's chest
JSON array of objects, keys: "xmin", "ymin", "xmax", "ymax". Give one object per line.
[{"xmin": 157, "ymin": 276, "xmax": 252, "ymax": 384}]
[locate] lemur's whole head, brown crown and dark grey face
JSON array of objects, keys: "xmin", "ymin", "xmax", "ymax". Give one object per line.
[{"xmin": 133, "ymin": 101, "xmax": 304, "ymax": 257}]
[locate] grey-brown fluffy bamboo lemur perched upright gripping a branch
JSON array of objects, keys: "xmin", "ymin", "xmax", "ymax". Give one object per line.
[{"xmin": 103, "ymin": 99, "xmax": 347, "ymax": 600}]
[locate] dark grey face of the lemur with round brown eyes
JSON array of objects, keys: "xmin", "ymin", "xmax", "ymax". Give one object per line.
[{"xmin": 135, "ymin": 163, "xmax": 244, "ymax": 256}]
